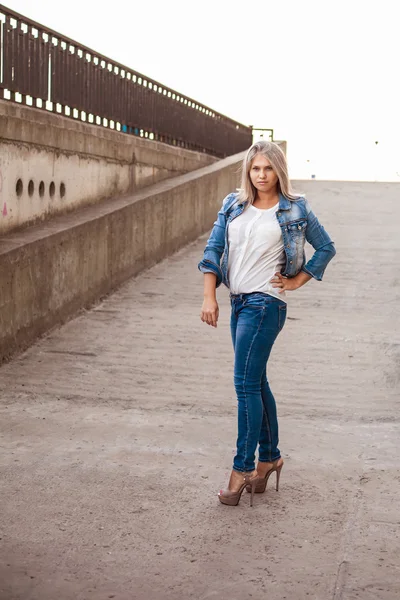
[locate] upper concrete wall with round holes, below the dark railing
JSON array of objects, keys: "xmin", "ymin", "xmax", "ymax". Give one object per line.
[{"xmin": 0, "ymin": 100, "xmax": 216, "ymax": 235}]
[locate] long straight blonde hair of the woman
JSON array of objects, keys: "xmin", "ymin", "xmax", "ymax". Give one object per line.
[{"xmin": 237, "ymin": 141, "xmax": 302, "ymax": 204}]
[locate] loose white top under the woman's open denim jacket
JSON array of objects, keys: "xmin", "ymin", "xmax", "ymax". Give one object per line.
[{"xmin": 228, "ymin": 204, "xmax": 286, "ymax": 302}]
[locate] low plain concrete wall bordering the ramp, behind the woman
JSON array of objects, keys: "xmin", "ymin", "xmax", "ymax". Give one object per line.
[{"xmin": 0, "ymin": 154, "xmax": 243, "ymax": 361}]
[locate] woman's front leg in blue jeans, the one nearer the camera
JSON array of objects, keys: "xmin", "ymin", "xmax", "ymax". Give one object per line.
[{"xmin": 233, "ymin": 297, "xmax": 282, "ymax": 471}]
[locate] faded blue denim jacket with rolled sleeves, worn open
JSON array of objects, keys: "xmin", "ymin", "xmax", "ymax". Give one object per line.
[{"xmin": 198, "ymin": 193, "xmax": 336, "ymax": 288}]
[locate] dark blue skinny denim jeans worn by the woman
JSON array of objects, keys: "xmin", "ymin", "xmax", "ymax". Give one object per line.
[{"xmin": 231, "ymin": 292, "xmax": 286, "ymax": 472}]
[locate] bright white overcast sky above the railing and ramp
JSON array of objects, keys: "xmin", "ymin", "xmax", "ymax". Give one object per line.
[{"xmin": 6, "ymin": 0, "xmax": 400, "ymax": 181}]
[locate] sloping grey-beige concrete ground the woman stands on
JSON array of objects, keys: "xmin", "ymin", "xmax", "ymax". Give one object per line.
[{"xmin": 0, "ymin": 181, "xmax": 400, "ymax": 600}]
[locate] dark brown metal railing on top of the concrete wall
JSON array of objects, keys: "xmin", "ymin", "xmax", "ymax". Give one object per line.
[{"xmin": 0, "ymin": 4, "xmax": 252, "ymax": 157}]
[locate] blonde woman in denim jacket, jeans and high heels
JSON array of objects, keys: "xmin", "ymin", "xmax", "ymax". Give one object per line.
[{"xmin": 199, "ymin": 141, "xmax": 336, "ymax": 506}]
